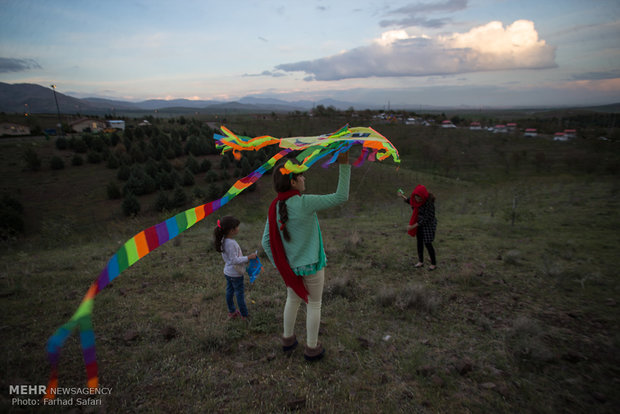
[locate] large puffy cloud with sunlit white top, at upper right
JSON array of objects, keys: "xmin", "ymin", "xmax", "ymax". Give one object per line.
[{"xmin": 276, "ymin": 20, "xmax": 557, "ymax": 81}]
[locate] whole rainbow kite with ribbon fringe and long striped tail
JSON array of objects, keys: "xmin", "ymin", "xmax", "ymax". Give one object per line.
[{"xmin": 45, "ymin": 125, "xmax": 400, "ymax": 399}]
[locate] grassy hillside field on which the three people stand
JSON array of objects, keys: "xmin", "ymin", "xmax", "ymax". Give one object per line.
[{"xmin": 0, "ymin": 121, "xmax": 620, "ymax": 413}]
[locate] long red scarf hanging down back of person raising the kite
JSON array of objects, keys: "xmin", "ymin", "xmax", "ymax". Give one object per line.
[{"xmin": 269, "ymin": 190, "xmax": 308, "ymax": 303}]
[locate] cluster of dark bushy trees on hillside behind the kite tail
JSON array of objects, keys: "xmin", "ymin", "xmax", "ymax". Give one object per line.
[{"xmin": 46, "ymin": 122, "xmax": 270, "ymax": 215}]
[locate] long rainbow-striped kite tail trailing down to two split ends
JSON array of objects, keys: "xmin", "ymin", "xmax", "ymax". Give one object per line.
[{"xmin": 44, "ymin": 149, "xmax": 292, "ymax": 399}]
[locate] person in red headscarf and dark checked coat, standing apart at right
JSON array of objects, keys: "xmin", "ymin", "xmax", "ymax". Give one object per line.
[{"xmin": 398, "ymin": 185, "xmax": 437, "ymax": 270}]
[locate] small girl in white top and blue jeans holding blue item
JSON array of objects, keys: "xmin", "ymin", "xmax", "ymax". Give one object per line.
[{"xmin": 213, "ymin": 216, "xmax": 256, "ymax": 320}]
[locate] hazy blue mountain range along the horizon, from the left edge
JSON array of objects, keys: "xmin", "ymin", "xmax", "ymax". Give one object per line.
[{"xmin": 0, "ymin": 82, "xmax": 378, "ymax": 115}]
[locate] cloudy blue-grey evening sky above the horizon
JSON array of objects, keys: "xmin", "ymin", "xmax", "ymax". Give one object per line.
[{"xmin": 0, "ymin": 0, "xmax": 620, "ymax": 107}]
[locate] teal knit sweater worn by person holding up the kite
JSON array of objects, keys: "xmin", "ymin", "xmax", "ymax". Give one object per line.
[{"xmin": 262, "ymin": 164, "xmax": 351, "ymax": 276}]
